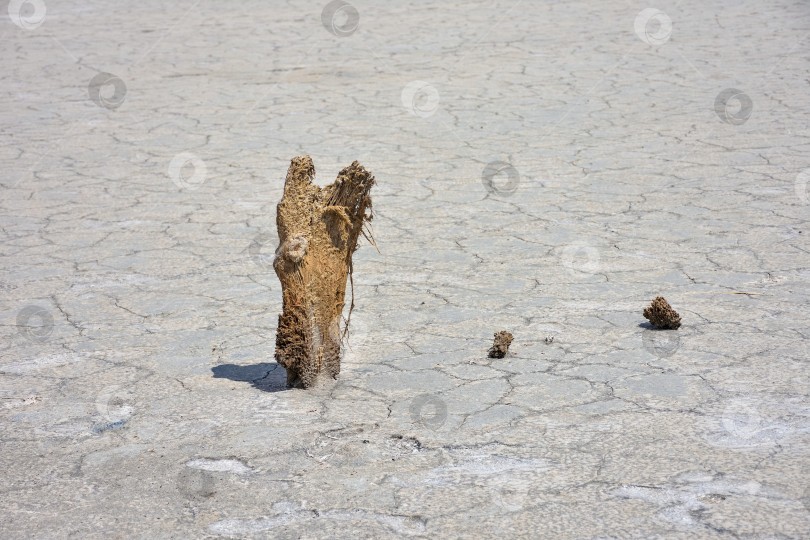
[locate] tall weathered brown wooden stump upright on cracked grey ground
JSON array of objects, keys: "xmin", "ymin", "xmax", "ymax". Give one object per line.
[{"xmin": 273, "ymin": 156, "xmax": 374, "ymax": 388}]
